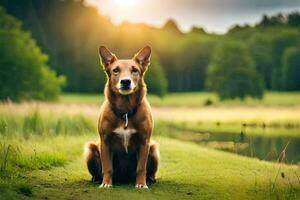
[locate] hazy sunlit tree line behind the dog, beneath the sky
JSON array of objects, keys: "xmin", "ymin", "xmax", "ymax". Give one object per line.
[{"xmin": 0, "ymin": 0, "xmax": 300, "ymax": 98}]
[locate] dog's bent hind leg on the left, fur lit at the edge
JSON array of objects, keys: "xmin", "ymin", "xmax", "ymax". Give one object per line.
[{"xmin": 84, "ymin": 142, "xmax": 102, "ymax": 182}]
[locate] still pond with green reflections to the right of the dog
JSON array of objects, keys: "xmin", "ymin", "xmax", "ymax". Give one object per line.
[{"xmin": 196, "ymin": 132, "xmax": 300, "ymax": 164}]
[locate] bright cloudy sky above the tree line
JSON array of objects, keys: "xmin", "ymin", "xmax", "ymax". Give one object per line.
[{"xmin": 86, "ymin": 0, "xmax": 300, "ymax": 33}]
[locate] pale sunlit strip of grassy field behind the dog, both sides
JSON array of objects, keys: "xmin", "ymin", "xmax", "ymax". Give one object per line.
[{"xmin": 0, "ymin": 102, "xmax": 300, "ymax": 137}]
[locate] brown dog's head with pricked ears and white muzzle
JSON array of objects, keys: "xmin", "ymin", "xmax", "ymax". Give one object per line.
[{"xmin": 99, "ymin": 46, "xmax": 151, "ymax": 95}]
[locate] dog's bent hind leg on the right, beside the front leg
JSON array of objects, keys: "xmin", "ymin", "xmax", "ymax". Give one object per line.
[{"xmin": 147, "ymin": 141, "xmax": 160, "ymax": 185}]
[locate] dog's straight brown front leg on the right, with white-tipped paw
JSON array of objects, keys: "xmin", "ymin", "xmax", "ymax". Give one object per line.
[{"xmin": 135, "ymin": 140, "xmax": 150, "ymax": 188}]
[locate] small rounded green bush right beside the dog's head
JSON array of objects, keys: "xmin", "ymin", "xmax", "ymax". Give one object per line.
[{"xmin": 145, "ymin": 58, "xmax": 168, "ymax": 97}]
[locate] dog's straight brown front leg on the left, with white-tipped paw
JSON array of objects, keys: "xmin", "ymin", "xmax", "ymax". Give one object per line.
[{"xmin": 100, "ymin": 142, "xmax": 113, "ymax": 187}]
